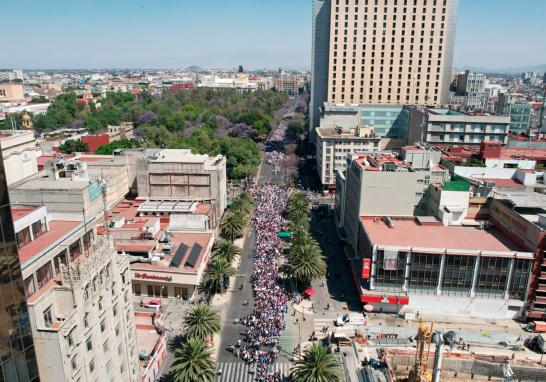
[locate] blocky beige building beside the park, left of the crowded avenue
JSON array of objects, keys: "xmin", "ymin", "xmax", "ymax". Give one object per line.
[{"xmin": 137, "ymin": 149, "xmax": 227, "ymax": 216}]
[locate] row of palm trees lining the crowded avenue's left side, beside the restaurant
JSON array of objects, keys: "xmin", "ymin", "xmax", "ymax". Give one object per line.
[{"xmin": 200, "ymin": 192, "xmax": 254, "ymax": 299}]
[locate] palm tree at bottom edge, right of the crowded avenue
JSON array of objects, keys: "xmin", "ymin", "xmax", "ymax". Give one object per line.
[{"xmin": 290, "ymin": 343, "xmax": 344, "ymax": 382}]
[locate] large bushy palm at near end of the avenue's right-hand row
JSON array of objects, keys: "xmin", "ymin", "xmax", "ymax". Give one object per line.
[{"xmin": 288, "ymin": 242, "xmax": 326, "ymax": 286}]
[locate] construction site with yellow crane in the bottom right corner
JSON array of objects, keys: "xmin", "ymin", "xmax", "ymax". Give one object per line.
[{"xmin": 323, "ymin": 315, "xmax": 546, "ymax": 382}]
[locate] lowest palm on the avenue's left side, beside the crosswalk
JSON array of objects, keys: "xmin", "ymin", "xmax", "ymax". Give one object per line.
[{"xmin": 171, "ymin": 338, "xmax": 216, "ymax": 382}]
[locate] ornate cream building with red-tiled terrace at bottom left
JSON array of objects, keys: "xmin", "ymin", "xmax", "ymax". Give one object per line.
[{"xmin": 12, "ymin": 205, "xmax": 140, "ymax": 382}]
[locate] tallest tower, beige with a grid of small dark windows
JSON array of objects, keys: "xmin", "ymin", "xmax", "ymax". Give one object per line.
[{"xmin": 310, "ymin": 0, "xmax": 458, "ymax": 128}]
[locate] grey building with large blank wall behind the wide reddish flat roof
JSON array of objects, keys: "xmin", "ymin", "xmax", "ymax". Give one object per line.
[{"xmin": 336, "ymin": 151, "xmax": 449, "ymax": 246}]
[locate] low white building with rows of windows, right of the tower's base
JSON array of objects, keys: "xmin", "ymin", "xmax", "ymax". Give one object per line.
[{"xmin": 408, "ymin": 108, "xmax": 510, "ymax": 145}]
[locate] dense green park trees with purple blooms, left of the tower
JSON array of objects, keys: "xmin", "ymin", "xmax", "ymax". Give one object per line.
[{"xmin": 0, "ymin": 88, "xmax": 288, "ymax": 179}]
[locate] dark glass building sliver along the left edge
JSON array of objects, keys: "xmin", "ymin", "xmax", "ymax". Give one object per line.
[{"xmin": 0, "ymin": 153, "xmax": 38, "ymax": 382}]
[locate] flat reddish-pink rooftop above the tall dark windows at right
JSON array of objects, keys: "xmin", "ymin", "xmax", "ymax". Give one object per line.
[{"xmin": 360, "ymin": 216, "xmax": 522, "ymax": 253}]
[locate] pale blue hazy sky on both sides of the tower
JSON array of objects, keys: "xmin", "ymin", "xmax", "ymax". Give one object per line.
[{"xmin": 0, "ymin": 0, "xmax": 546, "ymax": 68}]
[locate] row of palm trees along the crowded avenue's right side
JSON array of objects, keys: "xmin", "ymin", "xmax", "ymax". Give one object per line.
[{"xmin": 286, "ymin": 191, "xmax": 326, "ymax": 288}]
